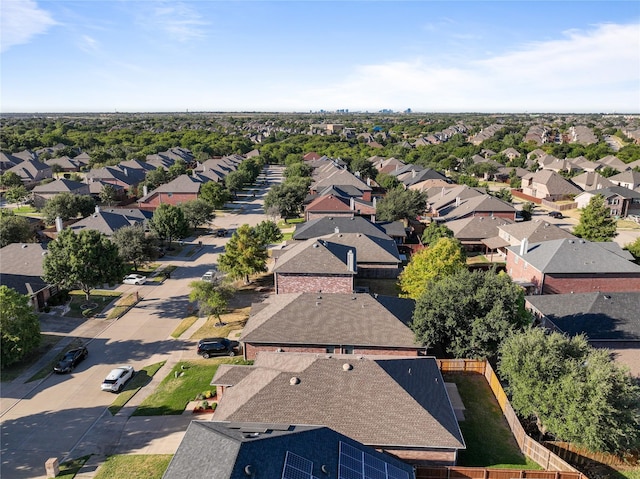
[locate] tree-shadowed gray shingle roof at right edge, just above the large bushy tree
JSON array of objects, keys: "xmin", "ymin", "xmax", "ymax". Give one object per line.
[{"xmin": 526, "ymin": 292, "xmax": 640, "ymax": 341}]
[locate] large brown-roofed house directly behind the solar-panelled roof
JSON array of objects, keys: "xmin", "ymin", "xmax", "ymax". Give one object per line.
[{"xmin": 211, "ymin": 352, "xmax": 465, "ymax": 465}]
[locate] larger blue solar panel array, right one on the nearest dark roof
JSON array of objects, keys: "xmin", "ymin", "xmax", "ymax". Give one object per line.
[{"xmin": 338, "ymin": 441, "xmax": 409, "ymax": 479}]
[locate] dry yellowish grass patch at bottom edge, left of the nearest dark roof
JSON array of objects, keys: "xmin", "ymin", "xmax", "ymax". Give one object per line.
[{"xmin": 92, "ymin": 454, "xmax": 173, "ymax": 479}]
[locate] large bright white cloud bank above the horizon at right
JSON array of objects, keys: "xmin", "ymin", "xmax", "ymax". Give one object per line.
[{"xmin": 294, "ymin": 24, "xmax": 640, "ymax": 112}]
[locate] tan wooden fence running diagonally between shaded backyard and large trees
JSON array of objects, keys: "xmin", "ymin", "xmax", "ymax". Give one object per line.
[{"xmin": 436, "ymin": 359, "xmax": 585, "ymax": 478}]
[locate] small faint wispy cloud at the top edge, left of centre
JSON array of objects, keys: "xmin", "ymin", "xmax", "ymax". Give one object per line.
[{"xmin": 153, "ymin": 2, "xmax": 209, "ymax": 42}]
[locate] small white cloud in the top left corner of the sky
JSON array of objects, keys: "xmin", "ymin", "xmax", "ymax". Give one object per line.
[{"xmin": 0, "ymin": 0, "xmax": 57, "ymax": 52}]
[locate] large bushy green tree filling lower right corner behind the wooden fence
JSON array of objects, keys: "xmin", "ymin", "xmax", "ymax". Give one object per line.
[{"xmin": 498, "ymin": 328, "xmax": 640, "ymax": 453}]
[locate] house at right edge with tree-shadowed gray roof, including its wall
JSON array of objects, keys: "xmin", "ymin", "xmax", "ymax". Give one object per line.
[{"xmin": 525, "ymin": 291, "xmax": 640, "ymax": 379}]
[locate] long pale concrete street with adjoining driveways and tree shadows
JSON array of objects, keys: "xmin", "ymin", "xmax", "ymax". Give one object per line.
[{"xmin": 0, "ymin": 167, "xmax": 282, "ymax": 479}]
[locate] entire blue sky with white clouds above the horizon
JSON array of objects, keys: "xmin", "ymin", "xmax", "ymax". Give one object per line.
[{"xmin": 0, "ymin": 0, "xmax": 640, "ymax": 113}]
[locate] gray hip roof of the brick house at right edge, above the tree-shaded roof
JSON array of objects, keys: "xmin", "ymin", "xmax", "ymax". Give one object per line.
[{"xmin": 507, "ymin": 239, "xmax": 640, "ymax": 274}]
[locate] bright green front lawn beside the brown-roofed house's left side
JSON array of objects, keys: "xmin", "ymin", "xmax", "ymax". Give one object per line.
[{"xmin": 131, "ymin": 358, "xmax": 248, "ymax": 416}]
